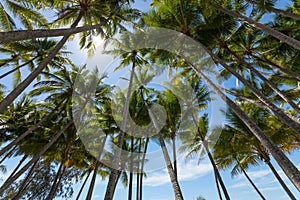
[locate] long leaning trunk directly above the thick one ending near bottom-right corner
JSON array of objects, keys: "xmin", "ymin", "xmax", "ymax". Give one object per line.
[{"xmin": 199, "ymin": 43, "xmax": 300, "ymax": 135}]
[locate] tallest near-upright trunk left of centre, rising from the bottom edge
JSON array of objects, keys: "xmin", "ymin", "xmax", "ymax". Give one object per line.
[{"xmin": 104, "ymin": 50, "xmax": 137, "ymax": 200}]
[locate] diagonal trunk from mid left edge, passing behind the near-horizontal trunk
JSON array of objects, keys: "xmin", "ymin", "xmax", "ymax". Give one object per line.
[{"xmin": 0, "ymin": 12, "xmax": 83, "ymax": 113}]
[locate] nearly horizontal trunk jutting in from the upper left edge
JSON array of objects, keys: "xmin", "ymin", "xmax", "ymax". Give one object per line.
[{"xmin": 0, "ymin": 21, "xmax": 106, "ymax": 44}]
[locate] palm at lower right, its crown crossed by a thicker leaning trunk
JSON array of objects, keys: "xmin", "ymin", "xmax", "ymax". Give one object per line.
[{"xmin": 216, "ymin": 104, "xmax": 297, "ymax": 199}]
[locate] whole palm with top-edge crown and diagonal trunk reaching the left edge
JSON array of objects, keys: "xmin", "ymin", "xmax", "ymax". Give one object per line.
[{"xmin": 0, "ymin": 0, "xmax": 138, "ymax": 113}]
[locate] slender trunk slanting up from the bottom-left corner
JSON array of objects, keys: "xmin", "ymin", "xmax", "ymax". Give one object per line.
[{"xmin": 0, "ymin": 121, "xmax": 73, "ymax": 194}]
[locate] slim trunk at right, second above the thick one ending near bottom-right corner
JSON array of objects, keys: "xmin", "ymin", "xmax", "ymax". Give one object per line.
[{"xmin": 224, "ymin": 46, "xmax": 300, "ymax": 113}]
